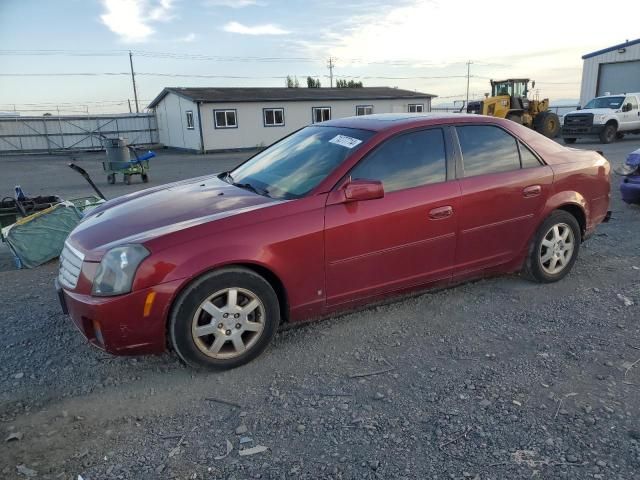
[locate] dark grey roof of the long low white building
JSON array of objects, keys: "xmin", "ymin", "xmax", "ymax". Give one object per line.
[{"xmin": 149, "ymin": 87, "xmax": 437, "ymax": 108}]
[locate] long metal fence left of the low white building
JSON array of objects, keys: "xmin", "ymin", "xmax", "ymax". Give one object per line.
[{"xmin": 0, "ymin": 113, "xmax": 158, "ymax": 154}]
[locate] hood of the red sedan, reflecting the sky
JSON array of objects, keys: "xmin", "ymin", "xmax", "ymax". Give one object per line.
[{"xmin": 68, "ymin": 175, "xmax": 280, "ymax": 255}]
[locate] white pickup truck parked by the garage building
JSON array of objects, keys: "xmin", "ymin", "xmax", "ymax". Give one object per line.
[{"xmin": 562, "ymin": 93, "xmax": 640, "ymax": 143}]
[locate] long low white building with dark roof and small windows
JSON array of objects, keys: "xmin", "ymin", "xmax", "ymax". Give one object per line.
[{"xmin": 149, "ymin": 87, "xmax": 435, "ymax": 152}]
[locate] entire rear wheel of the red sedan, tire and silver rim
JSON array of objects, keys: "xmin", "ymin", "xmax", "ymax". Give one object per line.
[{"xmin": 525, "ymin": 210, "xmax": 582, "ymax": 283}]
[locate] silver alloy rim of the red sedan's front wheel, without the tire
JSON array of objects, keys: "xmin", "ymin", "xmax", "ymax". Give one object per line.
[{"xmin": 191, "ymin": 288, "xmax": 265, "ymax": 359}]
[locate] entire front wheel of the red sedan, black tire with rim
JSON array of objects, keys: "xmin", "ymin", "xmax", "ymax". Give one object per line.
[{"xmin": 169, "ymin": 267, "xmax": 280, "ymax": 370}]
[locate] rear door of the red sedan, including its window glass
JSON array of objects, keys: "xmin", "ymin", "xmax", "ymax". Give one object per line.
[{"xmin": 455, "ymin": 125, "xmax": 553, "ymax": 274}]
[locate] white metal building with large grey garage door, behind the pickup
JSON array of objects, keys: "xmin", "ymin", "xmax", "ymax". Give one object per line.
[{"xmin": 580, "ymin": 38, "xmax": 640, "ymax": 105}]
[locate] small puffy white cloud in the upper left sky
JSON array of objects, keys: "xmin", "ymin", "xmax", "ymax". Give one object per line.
[{"xmin": 100, "ymin": 0, "xmax": 174, "ymax": 42}]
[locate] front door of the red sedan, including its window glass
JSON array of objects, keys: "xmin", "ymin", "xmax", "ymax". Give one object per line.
[{"xmin": 325, "ymin": 128, "xmax": 459, "ymax": 306}]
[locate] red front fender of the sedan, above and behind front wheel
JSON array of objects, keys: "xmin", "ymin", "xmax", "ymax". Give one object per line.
[{"xmin": 134, "ymin": 195, "xmax": 326, "ymax": 321}]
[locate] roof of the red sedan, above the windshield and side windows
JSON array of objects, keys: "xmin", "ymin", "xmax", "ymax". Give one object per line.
[{"xmin": 316, "ymin": 112, "xmax": 505, "ymax": 132}]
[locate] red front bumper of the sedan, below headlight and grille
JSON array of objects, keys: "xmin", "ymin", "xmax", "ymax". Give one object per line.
[{"xmin": 56, "ymin": 279, "xmax": 181, "ymax": 355}]
